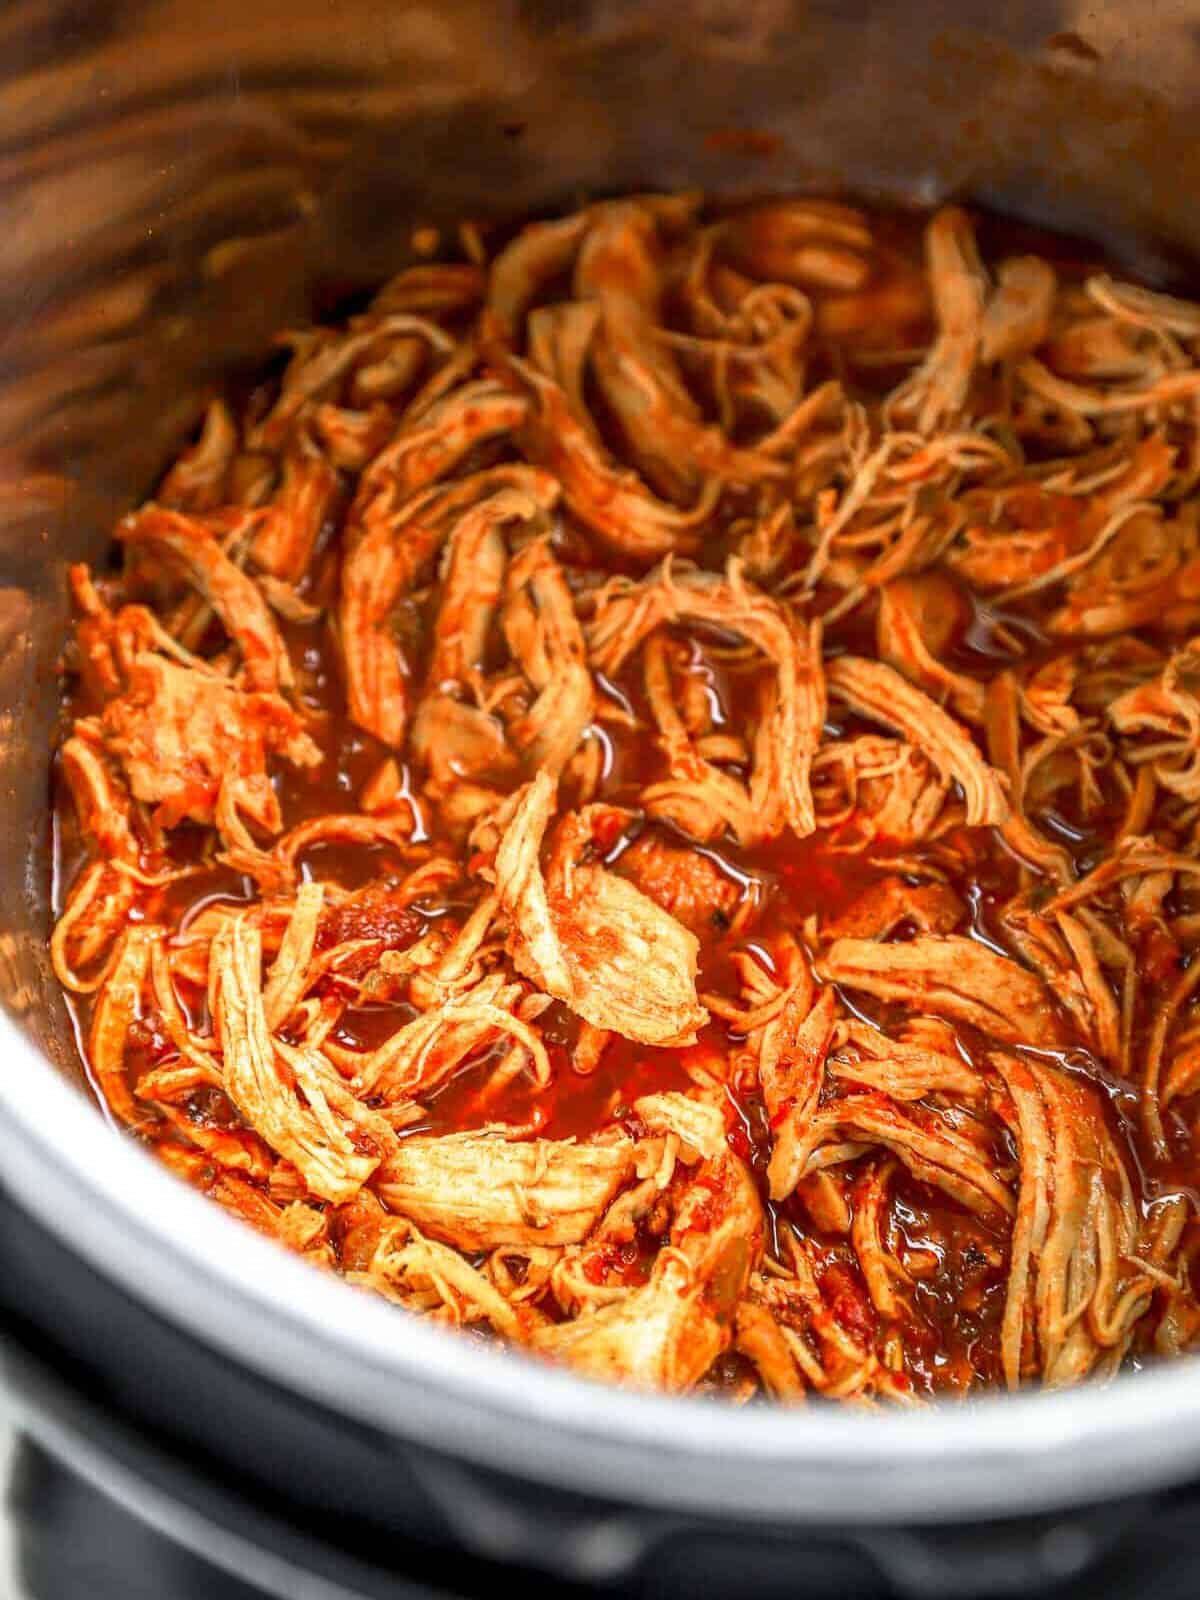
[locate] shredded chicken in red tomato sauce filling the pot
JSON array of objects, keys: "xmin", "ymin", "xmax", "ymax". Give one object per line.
[{"xmin": 53, "ymin": 197, "xmax": 1200, "ymax": 1402}]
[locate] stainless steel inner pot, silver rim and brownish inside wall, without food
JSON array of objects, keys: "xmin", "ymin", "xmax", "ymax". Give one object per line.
[{"xmin": 0, "ymin": 0, "xmax": 1200, "ymax": 1547}]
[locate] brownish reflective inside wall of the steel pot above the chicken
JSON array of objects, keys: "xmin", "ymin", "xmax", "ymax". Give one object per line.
[{"xmin": 0, "ymin": 0, "xmax": 1200, "ymax": 1074}]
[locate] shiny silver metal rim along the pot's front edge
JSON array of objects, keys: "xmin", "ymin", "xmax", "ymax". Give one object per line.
[{"xmin": 0, "ymin": 1016, "xmax": 1200, "ymax": 1525}]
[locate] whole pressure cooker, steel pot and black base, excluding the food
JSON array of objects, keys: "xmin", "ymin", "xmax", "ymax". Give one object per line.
[{"xmin": 0, "ymin": 0, "xmax": 1200, "ymax": 1600}]
